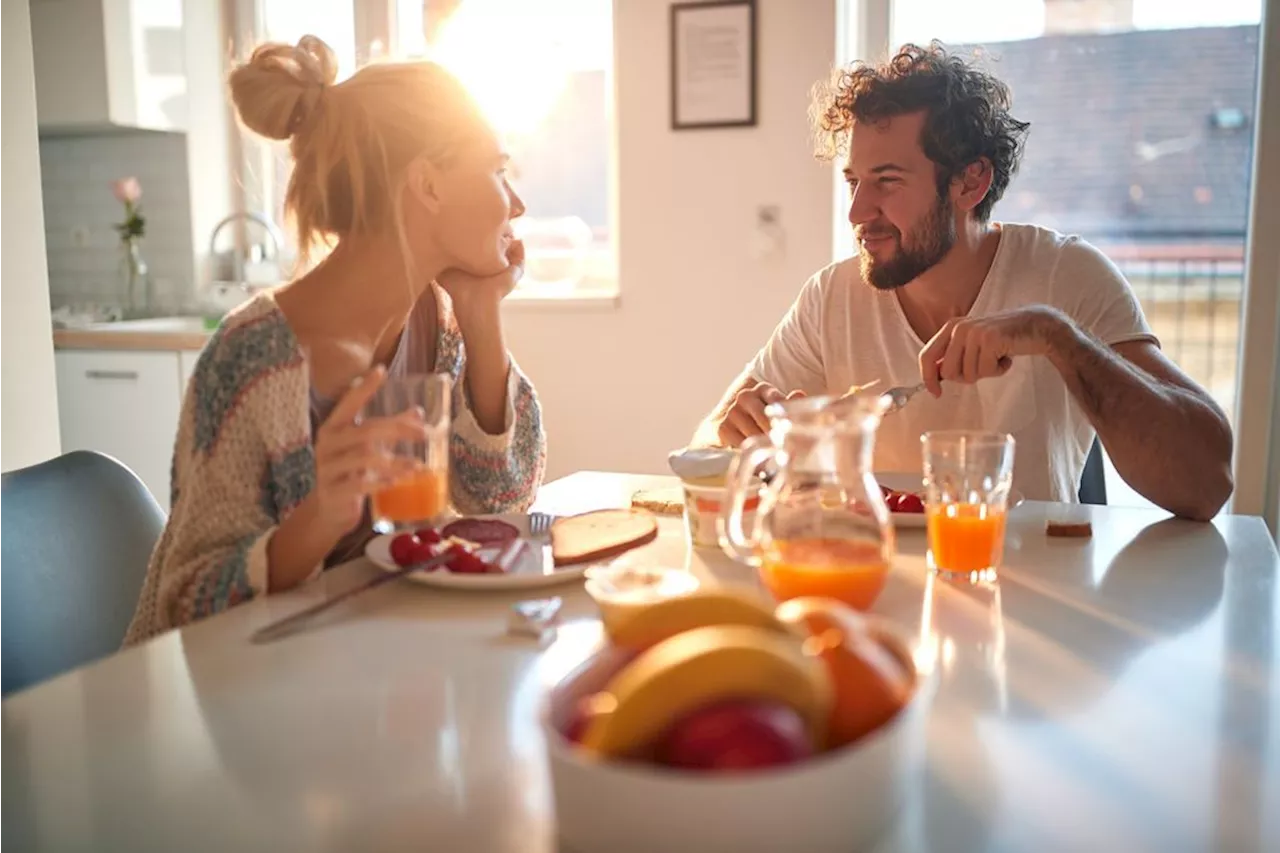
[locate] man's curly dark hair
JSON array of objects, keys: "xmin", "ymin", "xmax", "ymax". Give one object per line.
[{"xmin": 812, "ymin": 41, "xmax": 1030, "ymax": 222}]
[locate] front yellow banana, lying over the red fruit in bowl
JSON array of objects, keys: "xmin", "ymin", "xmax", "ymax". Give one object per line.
[{"xmin": 581, "ymin": 625, "xmax": 835, "ymax": 758}]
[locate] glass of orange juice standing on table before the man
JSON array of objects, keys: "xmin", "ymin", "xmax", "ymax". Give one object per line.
[{"xmin": 920, "ymin": 430, "xmax": 1014, "ymax": 581}]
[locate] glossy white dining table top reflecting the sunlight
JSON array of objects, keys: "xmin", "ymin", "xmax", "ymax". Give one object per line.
[{"xmin": 0, "ymin": 473, "xmax": 1280, "ymax": 853}]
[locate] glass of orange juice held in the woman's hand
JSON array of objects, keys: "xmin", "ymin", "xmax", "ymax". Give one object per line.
[{"xmin": 364, "ymin": 373, "xmax": 453, "ymax": 533}]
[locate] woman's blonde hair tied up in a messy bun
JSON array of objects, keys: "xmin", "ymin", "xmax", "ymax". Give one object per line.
[{"xmin": 229, "ymin": 36, "xmax": 486, "ymax": 261}]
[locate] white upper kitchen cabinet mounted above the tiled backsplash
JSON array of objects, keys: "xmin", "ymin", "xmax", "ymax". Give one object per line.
[{"xmin": 30, "ymin": 0, "xmax": 188, "ymax": 133}]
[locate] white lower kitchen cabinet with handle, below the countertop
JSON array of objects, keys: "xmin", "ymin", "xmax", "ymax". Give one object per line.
[{"xmin": 54, "ymin": 350, "xmax": 184, "ymax": 511}]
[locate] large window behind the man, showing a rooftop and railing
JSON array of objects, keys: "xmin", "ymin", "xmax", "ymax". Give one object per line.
[{"xmin": 841, "ymin": 0, "xmax": 1262, "ymax": 502}]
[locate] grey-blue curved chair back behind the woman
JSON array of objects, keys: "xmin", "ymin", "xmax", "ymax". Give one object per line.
[{"xmin": 0, "ymin": 451, "xmax": 165, "ymax": 695}]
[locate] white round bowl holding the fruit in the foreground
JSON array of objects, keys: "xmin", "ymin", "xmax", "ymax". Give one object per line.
[{"xmin": 541, "ymin": 617, "xmax": 932, "ymax": 853}]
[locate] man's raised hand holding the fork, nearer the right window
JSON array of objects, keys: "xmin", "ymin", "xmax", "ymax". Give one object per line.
[{"xmin": 920, "ymin": 305, "xmax": 1070, "ymax": 397}]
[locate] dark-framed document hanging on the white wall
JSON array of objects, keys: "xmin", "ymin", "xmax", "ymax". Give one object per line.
[{"xmin": 671, "ymin": 0, "xmax": 756, "ymax": 131}]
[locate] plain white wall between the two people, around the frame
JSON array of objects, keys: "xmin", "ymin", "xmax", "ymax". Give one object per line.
[{"xmin": 507, "ymin": 0, "xmax": 836, "ymax": 478}]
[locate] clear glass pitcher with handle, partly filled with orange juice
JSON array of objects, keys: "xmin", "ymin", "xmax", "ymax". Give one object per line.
[{"xmin": 719, "ymin": 394, "xmax": 893, "ymax": 610}]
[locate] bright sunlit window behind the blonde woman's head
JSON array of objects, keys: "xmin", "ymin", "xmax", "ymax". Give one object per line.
[{"xmin": 232, "ymin": 0, "xmax": 617, "ymax": 298}]
